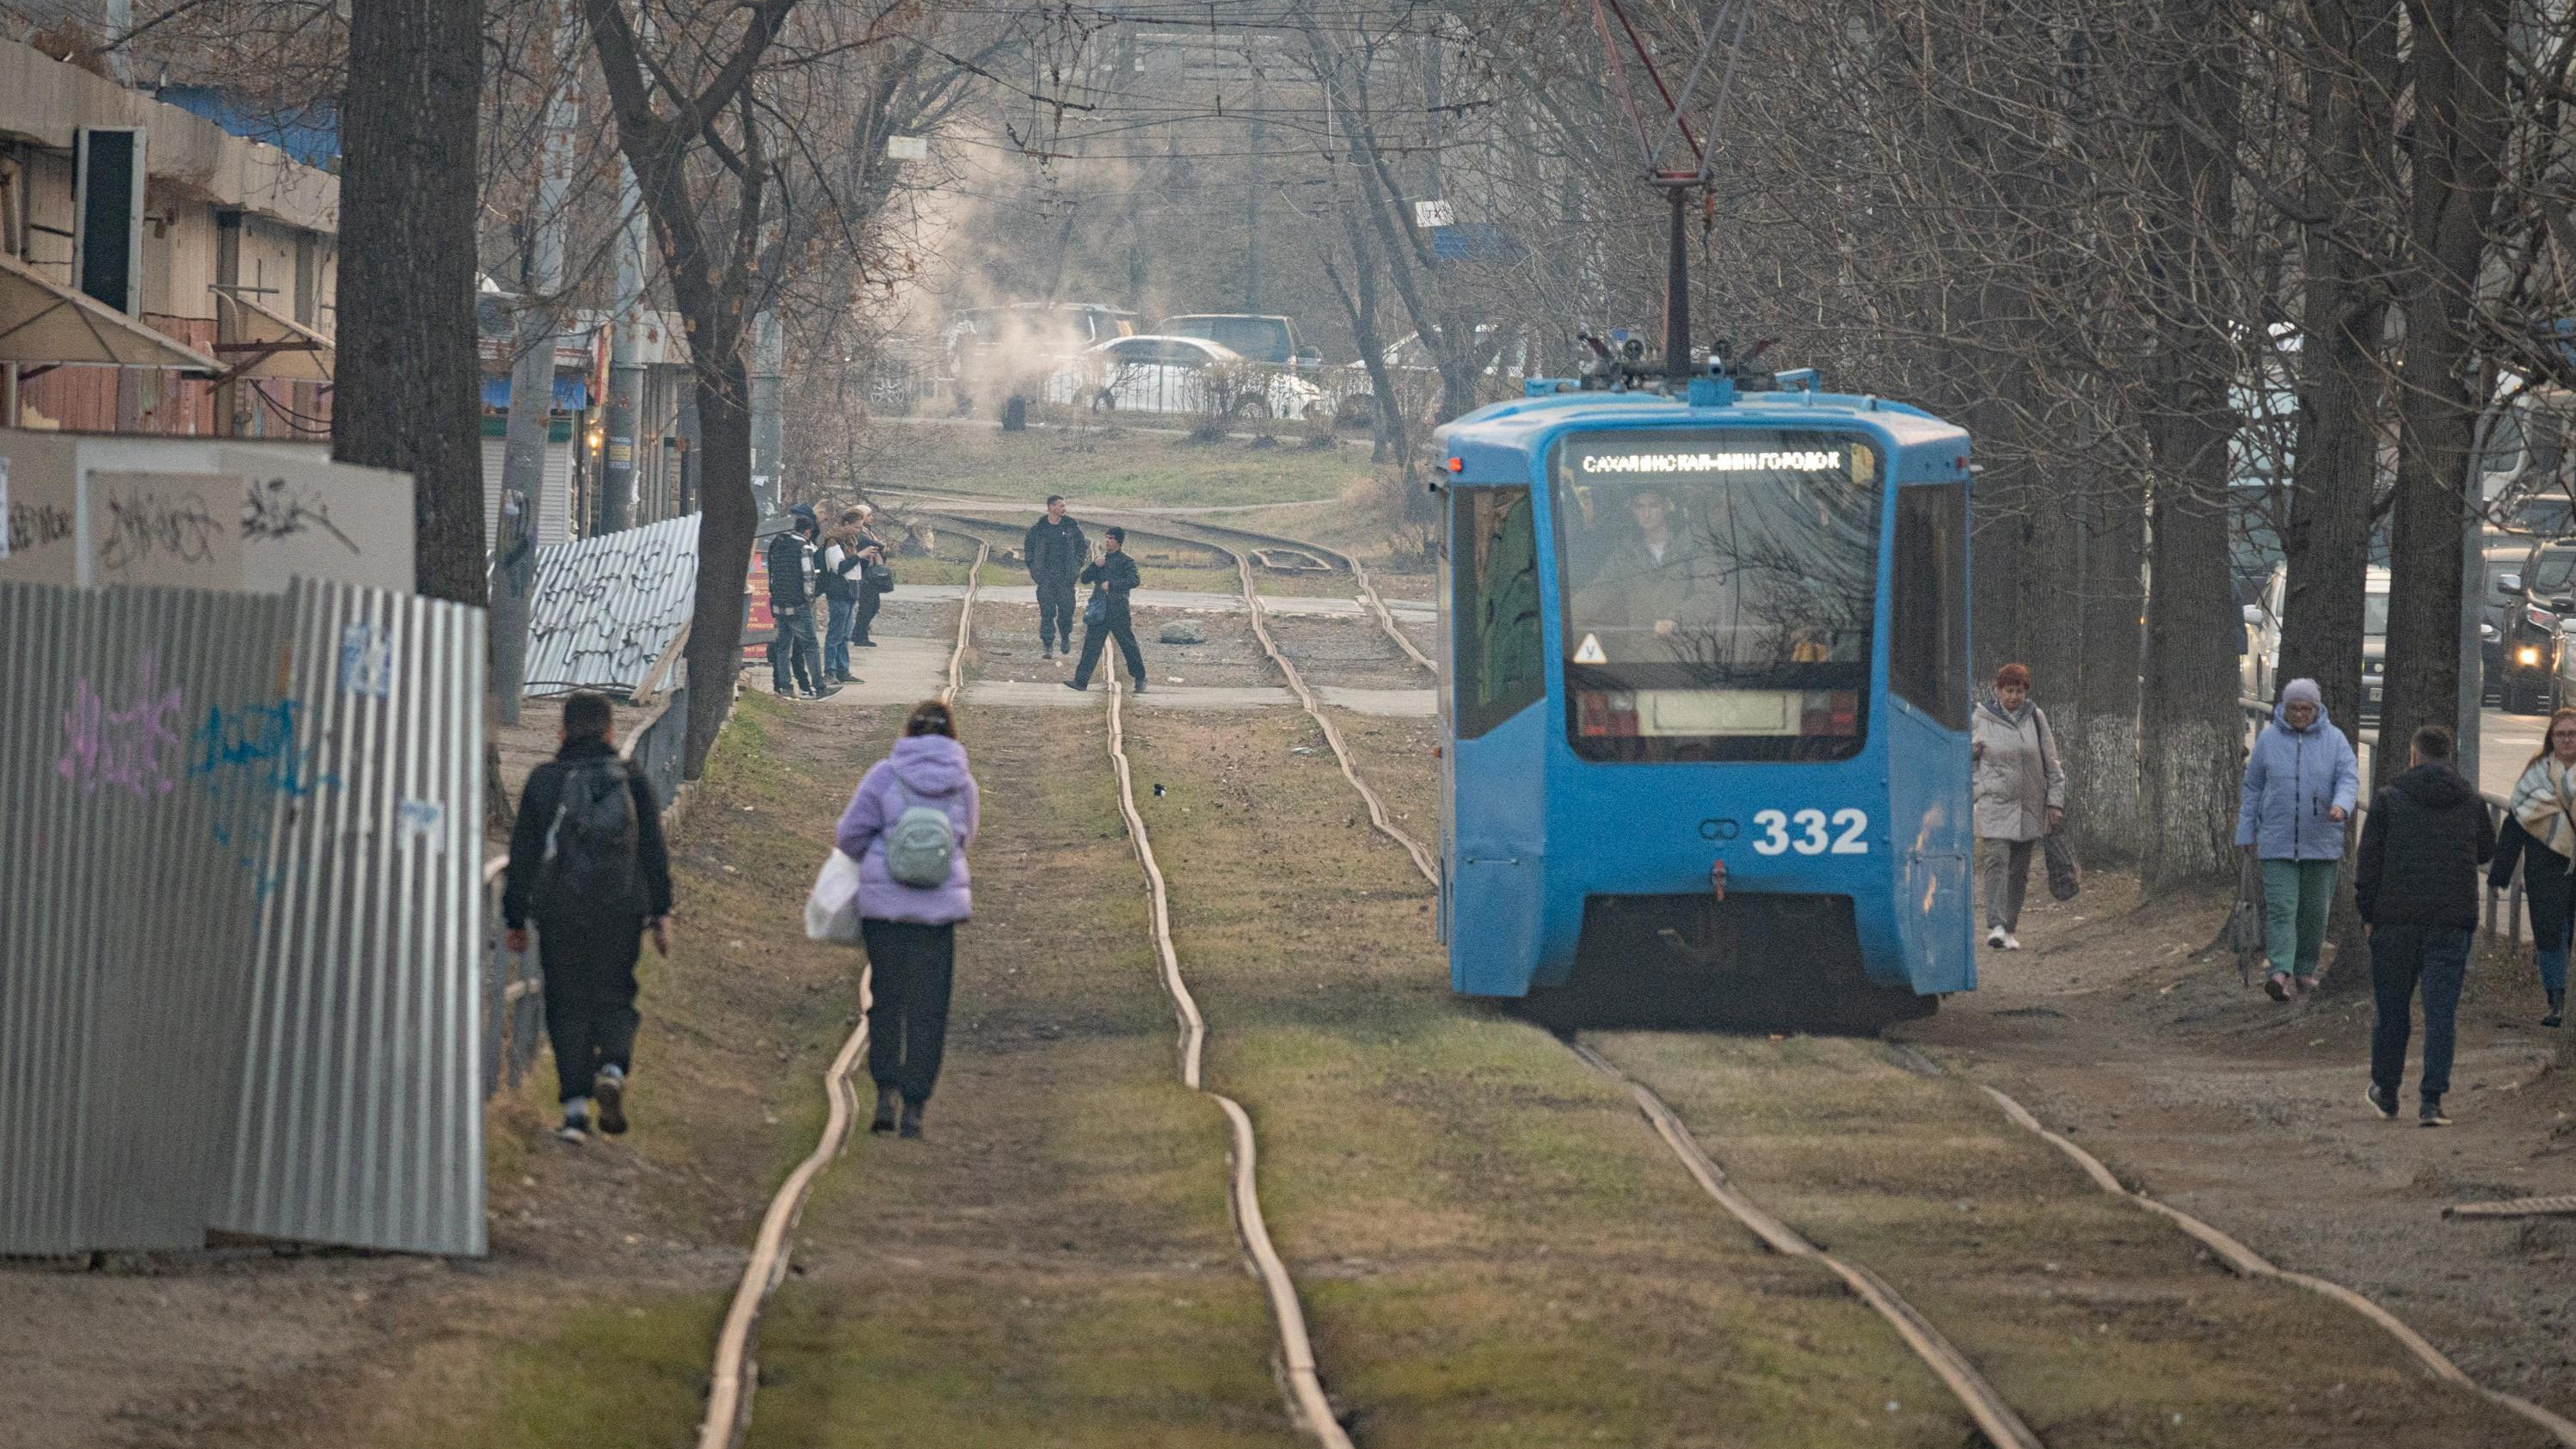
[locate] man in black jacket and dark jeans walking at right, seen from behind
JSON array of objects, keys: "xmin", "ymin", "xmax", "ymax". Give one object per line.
[{"xmin": 2352, "ymin": 726, "xmax": 2496, "ymax": 1127}]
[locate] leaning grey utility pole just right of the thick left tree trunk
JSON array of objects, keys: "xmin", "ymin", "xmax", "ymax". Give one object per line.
[{"xmin": 492, "ymin": 0, "xmax": 582, "ymax": 726}]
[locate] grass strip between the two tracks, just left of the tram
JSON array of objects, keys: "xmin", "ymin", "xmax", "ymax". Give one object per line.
[{"xmin": 1131, "ymin": 713, "xmax": 1970, "ymax": 1449}]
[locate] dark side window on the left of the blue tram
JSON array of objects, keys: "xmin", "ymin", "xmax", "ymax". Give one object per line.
[{"xmin": 1450, "ymin": 487, "xmax": 1548, "ymax": 739}]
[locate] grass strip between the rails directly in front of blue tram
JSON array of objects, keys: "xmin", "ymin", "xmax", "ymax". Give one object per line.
[{"xmin": 1584, "ymin": 1032, "xmax": 2550, "ymax": 1449}]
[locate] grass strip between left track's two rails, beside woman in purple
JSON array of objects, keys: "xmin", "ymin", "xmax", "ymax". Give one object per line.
[{"xmin": 750, "ymin": 708, "xmax": 1306, "ymax": 1449}]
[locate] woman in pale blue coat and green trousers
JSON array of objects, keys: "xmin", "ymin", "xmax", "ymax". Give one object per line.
[{"xmin": 2236, "ymin": 679, "xmax": 2362, "ymax": 1001}]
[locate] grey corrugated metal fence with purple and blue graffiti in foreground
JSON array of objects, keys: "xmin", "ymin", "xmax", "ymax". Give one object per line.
[{"xmin": 0, "ymin": 581, "xmax": 484, "ymax": 1254}]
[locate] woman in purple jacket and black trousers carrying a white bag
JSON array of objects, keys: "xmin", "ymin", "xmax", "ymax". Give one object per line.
[{"xmin": 834, "ymin": 700, "xmax": 976, "ymax": 1138}]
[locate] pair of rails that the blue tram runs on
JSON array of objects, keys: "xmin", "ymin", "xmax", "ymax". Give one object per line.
[{"xmin": 1159, "ymin": 509, "xmax": 2576, "ymax": 1449}]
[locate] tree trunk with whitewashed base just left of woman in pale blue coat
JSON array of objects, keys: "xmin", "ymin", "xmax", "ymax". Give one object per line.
[{"xmin": 2138, "ymin": 0, "xmax": 2244, "ymax": 891}]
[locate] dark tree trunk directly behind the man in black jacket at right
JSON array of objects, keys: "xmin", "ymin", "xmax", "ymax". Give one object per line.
[{"xmin": 2372, "ymin": 0, "xmax": 2509, "ymax": 783}]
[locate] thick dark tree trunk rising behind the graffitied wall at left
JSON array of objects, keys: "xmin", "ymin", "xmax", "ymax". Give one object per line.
[{"xmin": 332, "ymin": 0, "xmax": 484, "ymax": 607}]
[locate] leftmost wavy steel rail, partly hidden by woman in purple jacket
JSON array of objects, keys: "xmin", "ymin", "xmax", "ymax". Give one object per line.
[{"xmin": 698, "ymin": 541, "xmax": 992, "ymax": 1449}]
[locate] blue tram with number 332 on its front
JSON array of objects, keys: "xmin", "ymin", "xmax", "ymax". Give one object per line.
[{"xmin": 1437, "ymin": 373, "xmax": 1976, "ymax": 1029}]
